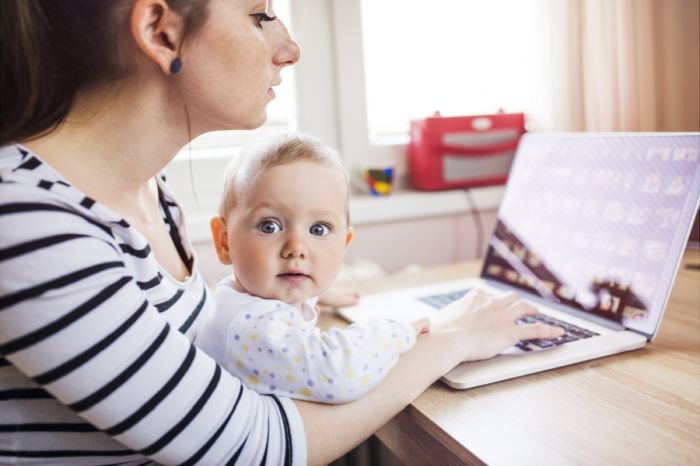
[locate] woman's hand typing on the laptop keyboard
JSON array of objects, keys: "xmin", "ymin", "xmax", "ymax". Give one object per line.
[{"xmin": 432, "ymin": 288, "xmax": 564, "ymax": 361}]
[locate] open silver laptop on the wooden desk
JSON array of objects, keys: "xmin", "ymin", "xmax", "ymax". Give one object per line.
[{"xmin": 339, "ymin": 133, "xmax": 700, "ymax": 389}]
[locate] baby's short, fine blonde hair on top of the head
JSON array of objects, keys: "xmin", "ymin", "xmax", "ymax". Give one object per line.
[{"xmin": 219, "ymin": 133, "xmax": 350, "ymax": 225}]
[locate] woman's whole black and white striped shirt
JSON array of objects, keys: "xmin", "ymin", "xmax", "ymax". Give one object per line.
[{"xmin": 0, "ymin": 145, "xmax": 306, "ymax": 464}]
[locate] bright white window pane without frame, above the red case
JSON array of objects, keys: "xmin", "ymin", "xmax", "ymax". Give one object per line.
[{"xmin": 361, "ymin": 0, "xmax": 547, "ymax": 142}]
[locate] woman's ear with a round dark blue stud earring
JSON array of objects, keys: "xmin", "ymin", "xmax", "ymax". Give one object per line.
[{"xmin": 131, "ymin": 0, "xmax": 184, "ymax": 74}]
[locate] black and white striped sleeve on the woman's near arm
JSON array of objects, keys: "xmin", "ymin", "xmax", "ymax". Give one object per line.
[{"xmin": 0, "ymin": 196, "xmax": 306, "ymax": 464}]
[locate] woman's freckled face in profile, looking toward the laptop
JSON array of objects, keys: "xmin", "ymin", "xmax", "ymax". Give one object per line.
[{"xmin": 179, "ymin": 0, "xmax": 299, "ymax": 134}]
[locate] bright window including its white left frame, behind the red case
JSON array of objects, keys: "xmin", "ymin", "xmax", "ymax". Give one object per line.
[{"xmin": 332, "ymin": 0, "xmax": 555, "ymax": 172}]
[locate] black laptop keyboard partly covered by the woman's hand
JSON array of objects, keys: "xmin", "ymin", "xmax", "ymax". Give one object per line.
[{"xmin": 418, "ymin": 289, "xmax": 598, "ymax": 351}]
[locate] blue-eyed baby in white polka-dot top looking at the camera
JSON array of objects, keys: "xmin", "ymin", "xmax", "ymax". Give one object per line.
[{"xmin": 195, "ymin": 134, "xmax": 429, "ymax": 403}]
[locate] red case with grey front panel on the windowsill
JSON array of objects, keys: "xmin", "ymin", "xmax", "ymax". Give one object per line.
[{"xmin": 408, "ymin": 113, "xmax": 525, "ymax": 191}]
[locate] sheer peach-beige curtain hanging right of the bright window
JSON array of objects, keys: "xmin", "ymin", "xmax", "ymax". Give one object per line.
[{"xmin": 550, "ymin": 0, "xmax": 700, "ymax": 131}]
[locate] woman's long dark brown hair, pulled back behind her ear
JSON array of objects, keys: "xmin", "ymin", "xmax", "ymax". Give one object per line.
[{"xmin": 0, "ymin": 0, "xmax": 207, "ymax": 147}]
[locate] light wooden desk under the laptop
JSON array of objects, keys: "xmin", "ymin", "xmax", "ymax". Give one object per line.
[{"xmin": 326, "ymin": 251, "xmax": 700, "ymax": 465}]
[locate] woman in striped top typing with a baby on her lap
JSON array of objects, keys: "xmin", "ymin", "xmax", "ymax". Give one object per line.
[{"xmin": 0, "ymin": 0, "xmax": 557, "ymax": 464}]
